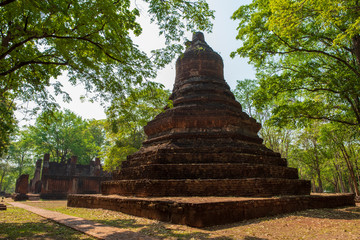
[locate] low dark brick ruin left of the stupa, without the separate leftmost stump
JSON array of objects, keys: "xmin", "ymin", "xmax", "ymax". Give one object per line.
[{"xmin": 39, "ymin": 154, "xmax": 111, "ymax": 199}]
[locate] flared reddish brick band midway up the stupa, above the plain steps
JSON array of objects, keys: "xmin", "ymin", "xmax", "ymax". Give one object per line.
[{"xmin": 143, "ymin": 116, "xmax": 263, "ymax": 146}]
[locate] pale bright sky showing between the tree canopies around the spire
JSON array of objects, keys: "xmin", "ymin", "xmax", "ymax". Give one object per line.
[{"xmin": 20, "ymin": 0, "xmax": 255, "ymax": 123}]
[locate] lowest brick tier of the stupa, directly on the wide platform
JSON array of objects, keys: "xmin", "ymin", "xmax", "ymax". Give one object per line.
[{"xmin": 101, "ymin": 178, "xmax": 311, "ymax": 197}]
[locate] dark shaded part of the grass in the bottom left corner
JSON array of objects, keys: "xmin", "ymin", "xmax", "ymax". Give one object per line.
[{"xmin": 0, "ymin": 220, "xmax": 94, "ymax": 239}]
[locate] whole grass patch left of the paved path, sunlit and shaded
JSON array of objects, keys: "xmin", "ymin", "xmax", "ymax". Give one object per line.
[{"xmin": 0, "ymin": 202, "xmax": 94, "ymax": 239}]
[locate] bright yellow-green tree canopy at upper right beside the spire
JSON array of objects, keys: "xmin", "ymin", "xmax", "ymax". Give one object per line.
[{"xmin": 232, "ymin": 0, "xmax": 360, "ymax": 129}]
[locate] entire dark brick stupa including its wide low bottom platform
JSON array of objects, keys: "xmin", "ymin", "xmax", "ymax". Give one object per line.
[{"xmin": 68, "ymin": 33, "xmax": 354, "ymax": 227}]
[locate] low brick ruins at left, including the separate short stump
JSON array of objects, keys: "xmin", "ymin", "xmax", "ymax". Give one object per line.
[{"xmin": 14, "ymin": 153, "xmax": 111, "ymax": 201}]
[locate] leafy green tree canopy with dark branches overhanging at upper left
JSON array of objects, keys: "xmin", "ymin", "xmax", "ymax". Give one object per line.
[{"xmin": 0, "ymin": 0, "xmax": 213, "ymax": 157}]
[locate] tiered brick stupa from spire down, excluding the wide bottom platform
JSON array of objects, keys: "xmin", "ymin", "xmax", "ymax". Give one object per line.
[{"xmin": 102, "ymin": 33, "xmax": 310, "ymax": 197}]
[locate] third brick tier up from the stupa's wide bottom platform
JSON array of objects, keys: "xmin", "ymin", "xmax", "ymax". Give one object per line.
[{"xmin": 121, "ymin": 151, "xmax": 287, "ymax": 168}]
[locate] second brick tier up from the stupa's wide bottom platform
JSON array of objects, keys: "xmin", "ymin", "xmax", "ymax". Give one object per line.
[{"xmin": 113, "ymin": 163, "xmax": 298, "ymax": 180}]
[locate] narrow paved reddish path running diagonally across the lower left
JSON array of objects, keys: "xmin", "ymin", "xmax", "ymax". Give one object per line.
[{"xmin": 9, "ymin": 202, "xmax": 155, "ymax": 240}]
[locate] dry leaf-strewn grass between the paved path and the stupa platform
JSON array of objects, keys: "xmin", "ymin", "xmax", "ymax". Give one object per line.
[{"xmin": 20, "ymin": 201, "xmax": 360, "ymax": 240}]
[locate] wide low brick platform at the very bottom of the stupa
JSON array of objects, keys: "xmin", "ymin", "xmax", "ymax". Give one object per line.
[{"xmin": 68, "ymin": 194, "xmax": 355, "ymax": 228}]
